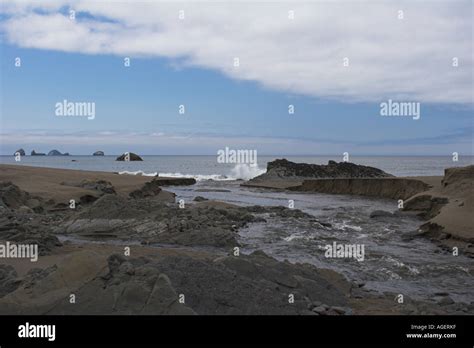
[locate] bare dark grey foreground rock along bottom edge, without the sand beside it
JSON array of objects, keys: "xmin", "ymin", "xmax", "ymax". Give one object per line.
[{"xmin": 39, "ymin": 252, "xmax": 348, "ymax": 315}]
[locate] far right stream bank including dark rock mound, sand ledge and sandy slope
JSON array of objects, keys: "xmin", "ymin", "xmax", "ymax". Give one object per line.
[{"xmin": 242, "ymin": 160, "xmax": 474, "ymax": 257}]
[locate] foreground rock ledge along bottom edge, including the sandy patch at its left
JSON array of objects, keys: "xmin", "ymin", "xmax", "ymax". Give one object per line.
[{"xmin": 0, "ymin": 251, "xmax": 350, "ymax": 315}]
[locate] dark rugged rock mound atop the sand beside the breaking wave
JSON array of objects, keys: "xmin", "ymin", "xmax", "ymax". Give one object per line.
[{"xmin": 250, "ymin": 159, "xmax": 392, "ymax": 182}]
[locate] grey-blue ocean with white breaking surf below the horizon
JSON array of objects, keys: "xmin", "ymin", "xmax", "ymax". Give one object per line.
[{"xmin": 0, "ymin": 155, "xmax": 474, "ymax": 180}]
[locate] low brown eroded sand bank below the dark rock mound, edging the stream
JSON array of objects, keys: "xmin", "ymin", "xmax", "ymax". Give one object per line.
[{"xmin": 289, "ymin": 178, "xmax": 430, "ymax": 200}]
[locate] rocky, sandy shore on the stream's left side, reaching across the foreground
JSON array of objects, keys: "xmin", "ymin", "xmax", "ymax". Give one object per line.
[{"xmin": 0, "ymin": 165, "xmax": 474, "ymax": 315}]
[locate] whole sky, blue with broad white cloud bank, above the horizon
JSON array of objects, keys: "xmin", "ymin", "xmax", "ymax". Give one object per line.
[{"xmin": 0, "ymin": 0, "xmax": 474, "ymax": 156}]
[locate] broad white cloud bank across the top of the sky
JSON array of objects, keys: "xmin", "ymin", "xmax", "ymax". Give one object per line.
[{"xmin": 1, "ymin": 0, "xmax": 473, "ymax": 103}]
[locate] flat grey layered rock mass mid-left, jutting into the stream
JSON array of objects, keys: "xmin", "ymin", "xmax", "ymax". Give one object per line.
[{"xmin": 56, "ymin": 193, "xmax": 311, "ymax": 248}]
